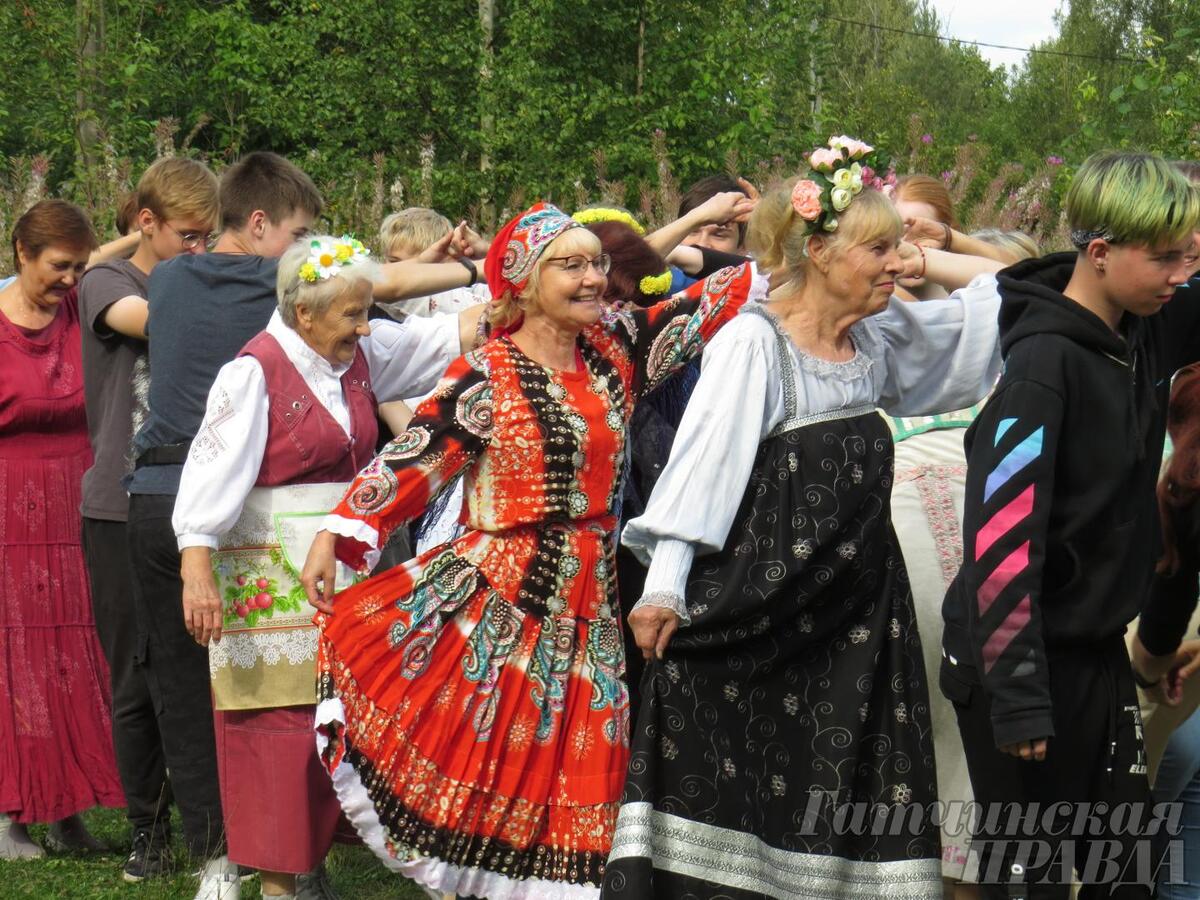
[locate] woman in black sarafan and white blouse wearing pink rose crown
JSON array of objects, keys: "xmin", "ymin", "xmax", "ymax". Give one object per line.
[{"xmin": 604, "ymin": 138, "xmax": 1000, "ymax": 900}]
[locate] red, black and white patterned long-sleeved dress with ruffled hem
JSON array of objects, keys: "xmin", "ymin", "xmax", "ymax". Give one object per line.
[{"xmin": 317, "ymin": 265, "xmax": 766, "ymax": 899}]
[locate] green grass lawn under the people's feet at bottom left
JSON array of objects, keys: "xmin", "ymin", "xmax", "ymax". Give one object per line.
[{"xmin": 0, "ymin": 810, "xmax": 426, "ymax": 900}]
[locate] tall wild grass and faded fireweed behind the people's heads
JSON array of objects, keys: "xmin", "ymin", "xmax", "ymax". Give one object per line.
[{"xmin": 0, "ymin": 119, "xmax": 1069, "ymax": 272}]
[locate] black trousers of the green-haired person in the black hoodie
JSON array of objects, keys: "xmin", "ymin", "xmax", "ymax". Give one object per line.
[{"xmin": 941, "ymin": 640, "xmax": 1177, "ymax": 900}]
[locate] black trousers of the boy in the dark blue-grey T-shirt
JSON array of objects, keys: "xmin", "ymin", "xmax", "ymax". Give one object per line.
[{"xmin": 128, "ymin": 494, "xmax": 224, "ymax": 858}]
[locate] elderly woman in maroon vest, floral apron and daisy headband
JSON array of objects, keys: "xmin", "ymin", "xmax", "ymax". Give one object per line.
[{"xmin": 173, "ymin": 236, "xmax": 478, "ymax": 900}]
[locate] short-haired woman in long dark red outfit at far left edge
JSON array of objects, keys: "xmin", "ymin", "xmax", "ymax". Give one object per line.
[{"xmin": 0, "ymin": 200, "xmax": 124, "ymax": 859}]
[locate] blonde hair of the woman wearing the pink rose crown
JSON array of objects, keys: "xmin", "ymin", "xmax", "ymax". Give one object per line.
[{"xmin": 746, "ymin": 179, "xmax": 904, "ymax": 283}]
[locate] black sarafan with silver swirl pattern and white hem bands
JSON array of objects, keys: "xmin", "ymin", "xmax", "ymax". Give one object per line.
[{"xmin": 602, "ymin": 309, "xmax": 941, "ymax": 900}]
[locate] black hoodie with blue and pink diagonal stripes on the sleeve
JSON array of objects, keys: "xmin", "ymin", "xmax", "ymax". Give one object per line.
[{"xmin": 942, "ymin": 253, "xmax": 1200, "ymax": 746}]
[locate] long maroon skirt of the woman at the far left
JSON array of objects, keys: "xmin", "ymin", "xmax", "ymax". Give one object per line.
[{"xmin": 0, "ymin": 441, "xmax": 125, "ymax": 822}]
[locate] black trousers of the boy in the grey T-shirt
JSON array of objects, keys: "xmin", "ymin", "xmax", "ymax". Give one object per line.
[{"xmin": 83, "ymin": 516, "xmax": 170, "ymax": 844}]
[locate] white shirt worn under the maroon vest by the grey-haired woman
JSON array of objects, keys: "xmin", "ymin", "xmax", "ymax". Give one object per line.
[{"xmin": 172, "ymin": 312, "xmax": 461, "ymax": 550}]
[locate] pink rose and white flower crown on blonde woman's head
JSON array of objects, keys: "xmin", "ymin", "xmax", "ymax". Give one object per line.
[{"xmin": 792, "ymin": 134, "xmax": 896, "ymax": 235}]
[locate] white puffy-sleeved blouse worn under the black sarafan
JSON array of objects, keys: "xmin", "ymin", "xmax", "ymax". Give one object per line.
[{"xmin": 622, "ymin": 275, "xmax": 1000, "ymax": 612}]
